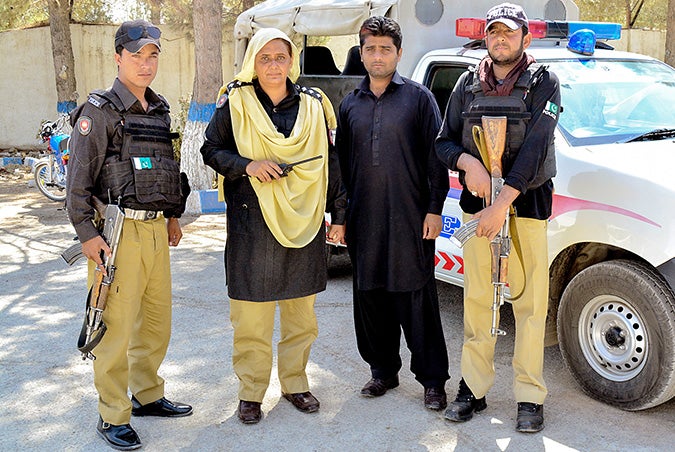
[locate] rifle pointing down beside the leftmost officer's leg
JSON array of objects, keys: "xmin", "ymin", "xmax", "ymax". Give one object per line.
[{"xmin": 61, "ymin": 196, "xmax": 124, "ymax": 360}]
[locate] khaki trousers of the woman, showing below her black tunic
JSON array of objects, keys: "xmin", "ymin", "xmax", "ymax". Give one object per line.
[{"xmin": 230, "ymin": 295, "xmax": 319, "ymax": 403}]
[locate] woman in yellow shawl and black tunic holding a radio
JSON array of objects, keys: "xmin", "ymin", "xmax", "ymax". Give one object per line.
[{"xmin": 201, "ymin": 28, "xmax": 346, "ymax": 424}]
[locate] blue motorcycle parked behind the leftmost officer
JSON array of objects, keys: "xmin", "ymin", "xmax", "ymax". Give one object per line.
[{"xmin": 33, "ymin": 116, "xmax": 70, "ymax": 201}]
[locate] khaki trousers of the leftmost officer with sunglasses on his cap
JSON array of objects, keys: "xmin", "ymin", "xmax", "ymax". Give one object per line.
[{"xmin": 89, "ymin": 217, "xmax": 171, "ymax": 425}]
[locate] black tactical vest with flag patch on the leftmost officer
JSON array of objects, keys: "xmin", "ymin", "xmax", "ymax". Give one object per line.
[{"xmin": 90, "ymin": 91, "xmax": 182, "ymax": 211}]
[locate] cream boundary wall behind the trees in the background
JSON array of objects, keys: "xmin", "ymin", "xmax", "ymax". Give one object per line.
[{"xmin": 0, "ymin": 25, "xmax": 665, "ymax": 149}]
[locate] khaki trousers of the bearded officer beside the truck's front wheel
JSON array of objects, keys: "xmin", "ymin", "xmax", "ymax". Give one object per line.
[{"xmin": 461, "ymin": 215, "xmax": 548, "ymax": 404}]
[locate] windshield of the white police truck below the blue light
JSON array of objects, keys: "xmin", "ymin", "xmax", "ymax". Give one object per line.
[{"xmin": 545, "ymin": 59, "xmax": 675, "ymax": 146}]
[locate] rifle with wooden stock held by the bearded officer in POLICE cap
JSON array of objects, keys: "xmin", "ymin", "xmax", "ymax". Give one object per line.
[{"xmin": 450, "ymin": 116, "xmax": 511, "ymax": 336}]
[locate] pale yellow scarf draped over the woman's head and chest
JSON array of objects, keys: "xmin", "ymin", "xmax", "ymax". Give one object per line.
[{"xmin": 221, "ymin": 28, "xmax": 336, "ymax": 248}]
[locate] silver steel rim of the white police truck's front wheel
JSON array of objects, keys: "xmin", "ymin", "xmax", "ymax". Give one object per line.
[{"xmin": 579, "ymin": 295, "xmax": 648, "ymax": 381}]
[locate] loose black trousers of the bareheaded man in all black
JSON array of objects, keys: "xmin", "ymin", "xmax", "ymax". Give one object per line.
[{"xmin": 354, "ymin": 277, "xmax": 450, "ymax": 388}]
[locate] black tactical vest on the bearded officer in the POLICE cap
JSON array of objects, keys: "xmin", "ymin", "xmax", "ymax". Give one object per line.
[{"xmin": 462, "ymin": 64, "xmax": 556, "ymax": 190}]
